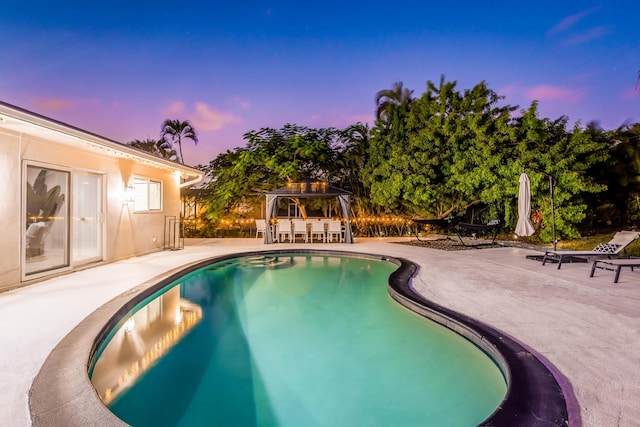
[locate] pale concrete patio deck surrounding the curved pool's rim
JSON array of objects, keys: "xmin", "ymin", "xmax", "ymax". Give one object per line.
[{"xmin": 0, "ymin": 239, "xmax": 640, "ymax": 426}]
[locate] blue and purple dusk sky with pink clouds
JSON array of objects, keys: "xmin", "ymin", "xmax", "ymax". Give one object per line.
[{"xmin": 0, "ymin": 0, "xmax": 640, "ymax": 165}]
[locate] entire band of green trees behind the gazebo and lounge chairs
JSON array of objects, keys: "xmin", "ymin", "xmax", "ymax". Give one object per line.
[{"xmin": 184, "ymin": 76, "xmax": 640, "ymax": 242}]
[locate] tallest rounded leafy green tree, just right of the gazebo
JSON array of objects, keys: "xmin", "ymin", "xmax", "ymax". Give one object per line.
[{"xmin": 363, "ymin": 76, "xmax": 513, "ymax": 218}]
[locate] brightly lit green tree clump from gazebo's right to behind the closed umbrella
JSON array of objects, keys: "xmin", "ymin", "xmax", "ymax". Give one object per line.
[{"xmin": 363, "ymin": 77, "xmax": 607, "ymax": 241}]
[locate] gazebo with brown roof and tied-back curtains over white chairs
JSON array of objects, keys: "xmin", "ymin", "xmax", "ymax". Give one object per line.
[{"xmin": 264, "ymin": 181, "xmax": 353, "ymax": 244}]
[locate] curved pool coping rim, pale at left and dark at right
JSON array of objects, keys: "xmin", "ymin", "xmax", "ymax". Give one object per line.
[{"xmin": 29, "ymin": 249, "xmax": 568, "ymax": 427}]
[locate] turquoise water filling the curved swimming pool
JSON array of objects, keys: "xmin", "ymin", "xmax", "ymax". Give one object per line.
[{"xmin": 92, "ymin": 255, "xmax": 506, "ymax": 426}]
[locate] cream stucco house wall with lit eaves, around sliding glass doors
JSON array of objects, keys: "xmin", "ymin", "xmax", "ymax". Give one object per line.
[{"xmin": 0, "ymin": 103, "xmax": 202, "ymax": 291}]
